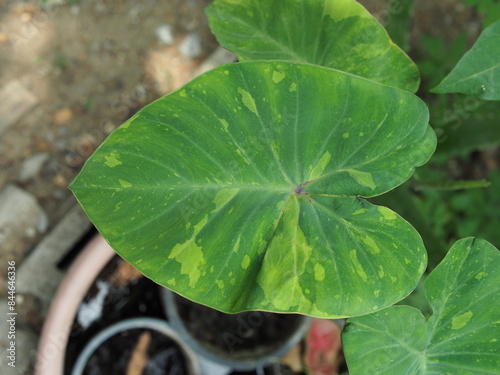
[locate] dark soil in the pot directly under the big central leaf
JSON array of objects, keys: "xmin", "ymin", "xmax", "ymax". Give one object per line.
[{"xmin": 175, "ymin": 296, "xmax": 301, "ymax": 359}]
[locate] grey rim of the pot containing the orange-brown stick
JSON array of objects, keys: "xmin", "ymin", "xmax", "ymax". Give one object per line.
[{"xmin": 71, "ymin": 317, "xmax": 201, "ymax": 375}]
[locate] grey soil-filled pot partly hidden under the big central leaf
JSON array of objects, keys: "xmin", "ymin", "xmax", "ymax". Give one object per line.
[{"xmin": 160, "ymin": 288, "xmax": 311, "ymax": 374}]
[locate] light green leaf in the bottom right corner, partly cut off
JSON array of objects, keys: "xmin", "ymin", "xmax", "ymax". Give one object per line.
[{"xmin": 342, "ymin": 238, "xmax": 500, "ymax": 375}]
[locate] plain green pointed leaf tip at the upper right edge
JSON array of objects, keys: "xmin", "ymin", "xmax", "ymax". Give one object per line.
[{"xmin": 431, "ymin": 21, "xmax": 500, "ymax": 100}]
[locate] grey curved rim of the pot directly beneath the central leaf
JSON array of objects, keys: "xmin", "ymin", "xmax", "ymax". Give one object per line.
[{"xmin": 160, "ymin": 286, "xmax": 312, "ymax": 370}]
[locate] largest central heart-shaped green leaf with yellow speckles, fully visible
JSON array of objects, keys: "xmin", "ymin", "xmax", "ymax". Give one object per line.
[{"xmin": 71, "ymin": 61, "xmax": 436, "ymax": 317}]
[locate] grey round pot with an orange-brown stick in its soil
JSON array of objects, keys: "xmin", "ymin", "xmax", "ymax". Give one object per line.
[{"xmin": 71, "ymin": 318, "xmax": 201, "ymax": 375}]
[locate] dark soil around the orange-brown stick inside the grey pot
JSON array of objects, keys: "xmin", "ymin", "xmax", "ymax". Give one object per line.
[{"xmin": 84, "ymin": 329, "xmax": 188, "ymax": 375}]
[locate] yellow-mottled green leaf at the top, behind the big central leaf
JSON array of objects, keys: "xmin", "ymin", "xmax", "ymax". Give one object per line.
[{"xmin": 207, "ymin": 0, "xmax": 420, "ymax": 92}]
